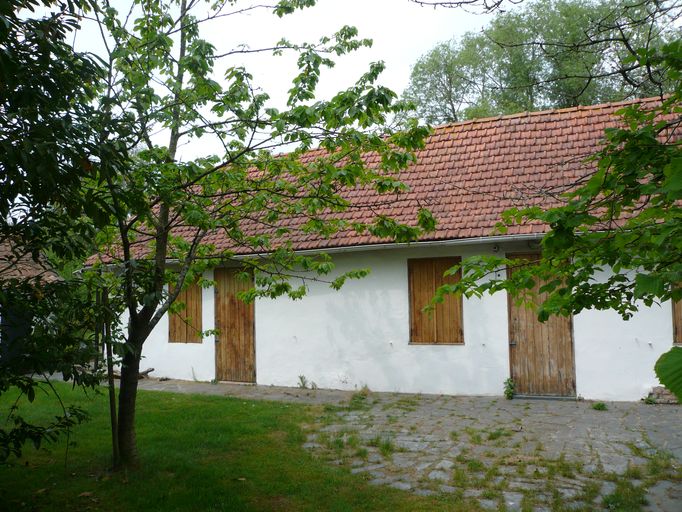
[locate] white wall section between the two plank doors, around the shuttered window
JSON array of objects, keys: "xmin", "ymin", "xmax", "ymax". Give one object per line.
[{"xmin": 255, "ymin": 245, "xmax": 509, "ymax": 395}]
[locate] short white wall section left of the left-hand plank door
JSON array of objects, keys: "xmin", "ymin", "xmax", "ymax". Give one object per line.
[{"xmin": 140, "ymin": 270, "xmax": 215, "ymax": 381}]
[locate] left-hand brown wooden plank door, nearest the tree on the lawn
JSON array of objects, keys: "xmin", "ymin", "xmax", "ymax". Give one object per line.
[{"xmin": 214, "ymin": 268, "xmax": 256, "ymax": 382}]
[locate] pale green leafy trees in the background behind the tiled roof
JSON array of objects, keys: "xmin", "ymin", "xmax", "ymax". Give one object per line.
[{"xmin": 404, "ymin": 0, "xmax": 671, "ymax": 123}]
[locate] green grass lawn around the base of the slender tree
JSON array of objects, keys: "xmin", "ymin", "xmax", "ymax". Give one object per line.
[{"xmin": 0, "ymin": 385, "xmax": 457, "ymax": 512}]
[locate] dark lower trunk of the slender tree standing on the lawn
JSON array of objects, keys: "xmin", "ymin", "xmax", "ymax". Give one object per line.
[{"xmin": 118, "ymin": 344, "xmax": 140, "ymax": 468}]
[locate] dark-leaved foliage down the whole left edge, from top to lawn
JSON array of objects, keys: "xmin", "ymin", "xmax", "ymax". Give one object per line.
[{"xmin": 0, "ymin": 0, "xmax": 116, "ymax": 460}]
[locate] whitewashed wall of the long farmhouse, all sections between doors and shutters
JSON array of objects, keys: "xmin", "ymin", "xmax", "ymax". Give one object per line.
[{"xmin": 134, "ymin": 244, "xmax": 672, "ymax": 400}]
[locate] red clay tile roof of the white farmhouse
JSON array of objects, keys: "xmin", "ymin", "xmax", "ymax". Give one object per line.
[{"xmin": 98, "ymin": 99, "xmax": 660, "ymax": 262}]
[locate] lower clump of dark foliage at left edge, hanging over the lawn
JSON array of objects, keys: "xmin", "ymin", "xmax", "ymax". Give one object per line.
[{"xmin": 0, "ymin": 270, "xmax": 100, "ymax": 461}]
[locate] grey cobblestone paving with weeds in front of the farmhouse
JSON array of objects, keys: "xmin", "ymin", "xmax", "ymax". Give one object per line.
[{"xmin": 140, "ymin": 380, "xmax": 682, "ymax": 512}]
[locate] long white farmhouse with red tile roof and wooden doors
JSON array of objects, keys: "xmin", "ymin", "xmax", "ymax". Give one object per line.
[{"xmin": 135, "ymin": 100, "xmax": 682, "ymax": 400}]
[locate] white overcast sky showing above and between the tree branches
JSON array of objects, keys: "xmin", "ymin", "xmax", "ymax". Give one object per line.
[{"xmin": 76, "ymin": 0, "xmax": 487, "ymax": 158}]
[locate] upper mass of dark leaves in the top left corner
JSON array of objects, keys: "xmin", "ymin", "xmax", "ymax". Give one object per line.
[{"xmin": 0, "ymin": 0, "xmax": 118, "ymax": 258}]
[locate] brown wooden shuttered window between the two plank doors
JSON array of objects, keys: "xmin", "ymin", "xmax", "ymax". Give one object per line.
[{"xmin": 407, "ymin": 257, "xmax": 464, "ymax": 345}]
